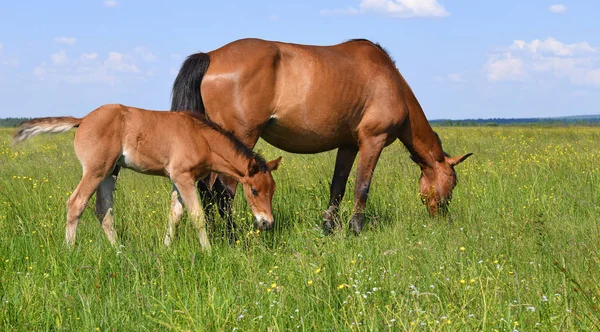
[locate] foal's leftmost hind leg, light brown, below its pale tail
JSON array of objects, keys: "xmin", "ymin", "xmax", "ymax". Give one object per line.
[{"xmin": 65, "ymin": 170, "xmax": 104, "ymax": 246}]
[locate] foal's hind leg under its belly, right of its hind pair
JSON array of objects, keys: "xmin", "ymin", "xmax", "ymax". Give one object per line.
[{"xmin": 96, "ymin": 166, "xmax": 119, "ymax": 244}]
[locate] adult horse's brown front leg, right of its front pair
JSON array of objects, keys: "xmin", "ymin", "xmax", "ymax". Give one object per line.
[{"xmin": 350, "ymin": 135, "xmax": 387, "ymax": 235}]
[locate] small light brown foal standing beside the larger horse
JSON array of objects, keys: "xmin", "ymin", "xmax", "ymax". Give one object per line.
[{"xmin": 14, "ymin": 105, "xmax": 281, "ymax": 250}]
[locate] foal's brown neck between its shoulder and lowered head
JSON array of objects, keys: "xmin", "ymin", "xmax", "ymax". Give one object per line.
[{"xmin": 204, "ymin": 128, "xmax": 251, "ymax": 182}]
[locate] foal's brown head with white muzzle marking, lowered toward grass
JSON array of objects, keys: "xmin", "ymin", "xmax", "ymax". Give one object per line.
[{"xmin": 241, "ymin": 157, "xmax": 281, "ymax": 230}]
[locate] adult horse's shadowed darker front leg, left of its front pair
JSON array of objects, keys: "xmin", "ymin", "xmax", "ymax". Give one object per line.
[{"xmin": 323, "ymin": 147, "xmax": 358, "ymax": 234}]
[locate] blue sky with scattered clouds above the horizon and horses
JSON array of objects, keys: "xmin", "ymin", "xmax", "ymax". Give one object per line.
[{"xmin": 0, "ymin": 0, "xmax": 600, "ymax": 119}]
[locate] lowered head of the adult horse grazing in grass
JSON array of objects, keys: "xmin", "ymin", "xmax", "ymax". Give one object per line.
[{"xmin": 411, "ymin": 134, "xmax": 473, "ymax": 216}]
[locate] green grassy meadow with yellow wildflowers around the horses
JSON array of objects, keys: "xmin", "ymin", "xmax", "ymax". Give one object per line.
[{"xmin": 0, "ymin": 127, "xmax": 600, "ymax": 331}]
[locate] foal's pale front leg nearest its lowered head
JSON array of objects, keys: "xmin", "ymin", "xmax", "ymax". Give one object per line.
[{"xmin": 173, "ymin": 174, "xmax": 211, "ymax": 251}]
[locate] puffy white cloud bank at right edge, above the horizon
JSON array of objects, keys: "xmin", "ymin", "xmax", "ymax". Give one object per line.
[{"xmin": 484, "ymin": 38, "xmax": 600, "ymax": 85}]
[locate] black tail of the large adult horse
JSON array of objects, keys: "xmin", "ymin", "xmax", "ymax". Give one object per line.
[{"xmin": 171, "ymin": 53, "xmax": 210, "ymax": 114}]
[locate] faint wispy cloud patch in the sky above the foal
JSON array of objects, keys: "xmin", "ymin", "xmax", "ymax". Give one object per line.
[{"xmin": 33, "ymin": 49, "xmax": 156, "ymax": 85}]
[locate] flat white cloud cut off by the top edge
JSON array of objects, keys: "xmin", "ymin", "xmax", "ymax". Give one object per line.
[{"xmin": 321, "ymin": 0, "xmax": 450, "ymax": 18}]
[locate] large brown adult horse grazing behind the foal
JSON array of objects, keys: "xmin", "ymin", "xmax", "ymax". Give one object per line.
[{"xmin": 171, "ymin": 39, "xmax": 471, "ymax": 233}]
